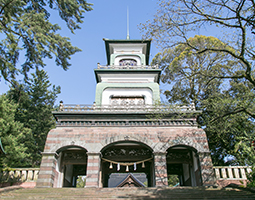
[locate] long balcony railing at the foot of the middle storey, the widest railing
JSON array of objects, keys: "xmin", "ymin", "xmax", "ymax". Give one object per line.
[{"xmin": 58, "ymin": 103, "xmax": 198, "ymax": 113}]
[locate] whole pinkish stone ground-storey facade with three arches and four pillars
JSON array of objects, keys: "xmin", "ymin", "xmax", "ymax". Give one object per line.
[{"xmin": 37, "ymin": 120, "xmax": 214, "ymax": 187}]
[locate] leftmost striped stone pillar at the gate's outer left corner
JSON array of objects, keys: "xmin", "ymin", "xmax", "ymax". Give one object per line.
[{"xmin": 36, "ymin": 153, "xmax": 57, "ymax": 187}]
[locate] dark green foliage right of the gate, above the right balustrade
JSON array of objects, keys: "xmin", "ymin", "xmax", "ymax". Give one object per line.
[{"xmin": 205, "ymin": 81, "xmax": 255, "ymax": 165}]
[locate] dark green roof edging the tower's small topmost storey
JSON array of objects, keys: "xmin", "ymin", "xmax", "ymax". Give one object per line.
[{"xmin": 103, "ymin": 38, "xmax": 151, "ymax": 65}]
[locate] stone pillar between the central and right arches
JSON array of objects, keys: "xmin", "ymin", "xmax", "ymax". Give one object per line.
[{"xmin": 154, "ymin": 152, "xmax": 168, "ymax": 187}]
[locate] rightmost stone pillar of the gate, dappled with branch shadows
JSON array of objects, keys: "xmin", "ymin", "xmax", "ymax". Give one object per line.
[{"xmin": 198, "ymin": 152, "xmax": 216, "ymax": 186}]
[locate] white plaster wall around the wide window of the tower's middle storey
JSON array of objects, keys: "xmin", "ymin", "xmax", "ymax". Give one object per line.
[{"xmin": 102, "ymin": 88, "xmax": 153, "ymax": 105}]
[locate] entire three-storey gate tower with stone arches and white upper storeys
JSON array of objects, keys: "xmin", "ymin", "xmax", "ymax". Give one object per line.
[{"xmin": 37, "ymin": 39, "xmax": 214, "ymax": 187}]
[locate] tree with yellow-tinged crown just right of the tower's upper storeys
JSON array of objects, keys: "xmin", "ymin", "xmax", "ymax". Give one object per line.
[{"xmin": 152, "ymin": 36, "xmax": 229, "ymax": 106}]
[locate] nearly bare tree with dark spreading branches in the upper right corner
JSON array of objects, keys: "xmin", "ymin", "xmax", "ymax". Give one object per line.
[{"xmin": 142, "ymin": 0, "xmax": 255, "ymax": 118}]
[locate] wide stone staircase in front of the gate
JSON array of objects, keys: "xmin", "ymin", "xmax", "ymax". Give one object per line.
[{"xmin": 0, "ymin": 186, "xmax": 255, "ymax": 200}]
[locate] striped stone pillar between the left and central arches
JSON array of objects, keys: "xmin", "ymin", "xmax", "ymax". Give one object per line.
[{"xmin": 85, "ymin": 152, "xmax": 101, "ymax": 187}]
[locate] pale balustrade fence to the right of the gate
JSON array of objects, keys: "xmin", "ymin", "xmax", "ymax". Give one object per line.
[{"xmin": 213, "ymin": 166, "xmax": 251, "ymax": 180}]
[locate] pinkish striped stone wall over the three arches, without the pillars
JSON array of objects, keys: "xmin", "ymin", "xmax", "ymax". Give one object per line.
[{"xmin": 44, "ymin": 127, "xmax": 209, "ymax": 153}]
